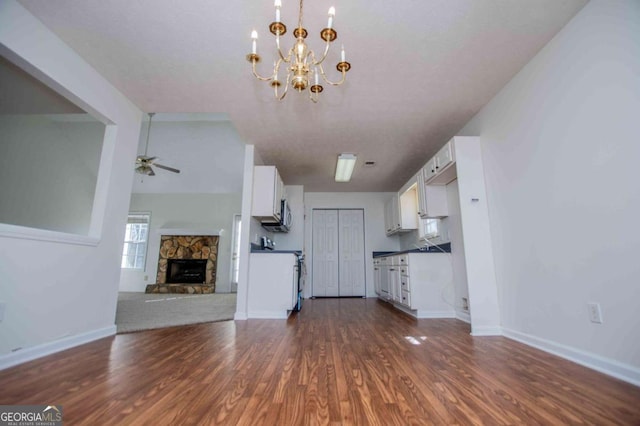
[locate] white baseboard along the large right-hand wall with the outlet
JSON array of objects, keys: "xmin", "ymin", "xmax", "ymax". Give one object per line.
[{"xmin": 503, "ymin": 328, "xmax": 640, "ymax": 386}]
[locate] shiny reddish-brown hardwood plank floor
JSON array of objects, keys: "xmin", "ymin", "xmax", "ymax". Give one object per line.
[{"xmin": 0, "ymin": 299, "xmax": 640, "ymax": 425}]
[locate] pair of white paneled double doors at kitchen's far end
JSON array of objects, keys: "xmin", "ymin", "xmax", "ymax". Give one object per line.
[{"xmin": 311, "ymin": 209, "xmax": 366, "ymax": 297}]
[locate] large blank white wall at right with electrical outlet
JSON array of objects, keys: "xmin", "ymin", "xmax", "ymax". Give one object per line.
[{"xmin": 461, "ymin": 0, "xmax": 640, "ymax": 383}]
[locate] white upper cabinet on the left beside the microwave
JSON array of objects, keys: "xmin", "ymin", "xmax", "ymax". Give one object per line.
[{"xmin": 251, "ymin": 166, "xmax": 284, "ymax": 221}]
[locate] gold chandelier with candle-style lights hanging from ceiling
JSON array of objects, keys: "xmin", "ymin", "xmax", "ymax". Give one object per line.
[{"xmin": 247, "ymin": 0, "xmax": 351, "ymax": 102}]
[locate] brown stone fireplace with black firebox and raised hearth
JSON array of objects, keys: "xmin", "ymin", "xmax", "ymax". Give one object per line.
[{"xmin": 146, "ymin": 235, "xmax": 219, "ymax": 294}]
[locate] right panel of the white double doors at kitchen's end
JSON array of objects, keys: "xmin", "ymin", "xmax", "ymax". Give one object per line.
[{"xmin": 338, "ymin": 210, "xmax": 365, "ymax": 296}]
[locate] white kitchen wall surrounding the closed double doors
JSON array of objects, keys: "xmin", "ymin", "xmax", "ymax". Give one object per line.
[{"xmin": 304, "ymin": 192, "xmax": 400, "ymax": 298}]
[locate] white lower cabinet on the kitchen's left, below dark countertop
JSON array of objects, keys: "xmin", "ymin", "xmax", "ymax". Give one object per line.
[{"xmin": 247, "ymin": 253, "xmax": 298, "ymax": 318}]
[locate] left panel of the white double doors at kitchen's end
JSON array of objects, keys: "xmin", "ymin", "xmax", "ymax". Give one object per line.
[{"xmin": 312, "ymin": 209, "xmax": 340, "ymax": 297}]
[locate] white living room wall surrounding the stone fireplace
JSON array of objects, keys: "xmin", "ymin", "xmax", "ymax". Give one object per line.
[{"xmin": 120, "ymin": 193, "xmax": 242, "ymax": 293}]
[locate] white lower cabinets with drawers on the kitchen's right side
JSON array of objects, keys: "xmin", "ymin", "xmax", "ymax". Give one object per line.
[{"xmin": 378, "ymin": 253, "xmax": 455, "ymax": 318}]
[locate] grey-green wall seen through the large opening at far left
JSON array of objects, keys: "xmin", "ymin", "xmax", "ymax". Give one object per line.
[{"xmin": 0, "ymin": 114, "xmax": 105, "ymax": 235}]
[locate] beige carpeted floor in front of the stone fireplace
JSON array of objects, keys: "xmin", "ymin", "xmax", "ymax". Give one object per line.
[{"xmin": 116, "ymin": 292, "xmax": 236, "ymax": 333}]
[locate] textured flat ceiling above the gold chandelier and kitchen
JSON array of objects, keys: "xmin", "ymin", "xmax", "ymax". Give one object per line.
[{"xmin": 20, "ymin": 0, "xmax": 587, "ymax": 191}]
